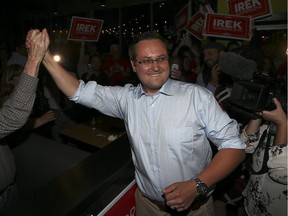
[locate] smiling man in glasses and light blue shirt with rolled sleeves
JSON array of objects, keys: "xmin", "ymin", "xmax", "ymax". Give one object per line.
[{"xmin": 28, "ymin": 30, "xmax": 245, "ymax": 216}]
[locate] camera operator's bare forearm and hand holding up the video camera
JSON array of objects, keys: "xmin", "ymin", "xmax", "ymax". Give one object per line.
[{"xmin": 262, "ymin": 98, "xmax": 287, "ymax": 145}]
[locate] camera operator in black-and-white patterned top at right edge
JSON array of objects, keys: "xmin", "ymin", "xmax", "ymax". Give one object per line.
[{"xmin": 241, "ymin": 97, "xmax": 287, "ymax": 216}]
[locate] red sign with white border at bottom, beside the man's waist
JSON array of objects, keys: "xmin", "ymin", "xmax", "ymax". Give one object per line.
[{"xmin": 98, "ymin": 180, "xmax": 137, "ymax": 216}]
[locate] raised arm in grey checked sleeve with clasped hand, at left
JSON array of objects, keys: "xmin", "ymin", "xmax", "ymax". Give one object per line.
[{"xmin": 0, "ymin": 29, "xmax": 49, "ymax": 138}]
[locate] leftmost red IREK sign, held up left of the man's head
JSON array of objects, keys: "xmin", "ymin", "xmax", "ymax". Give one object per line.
[{"xmin": 68, "ymin": 17, "xmax": 103, "ymax": 41}]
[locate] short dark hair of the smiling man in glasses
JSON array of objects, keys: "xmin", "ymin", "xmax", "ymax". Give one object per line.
[{"xmin": 128, "ymin": 31, "xmax": 168, "ymax": 60}]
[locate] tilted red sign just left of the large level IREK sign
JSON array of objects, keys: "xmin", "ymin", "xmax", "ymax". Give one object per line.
[{"xmin": 185, "ymin": 11, "xmax": 205, "ymax": 40}]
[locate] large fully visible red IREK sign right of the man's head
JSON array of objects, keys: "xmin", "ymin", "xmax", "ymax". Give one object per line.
[{"xmin": 203, "ymin": 13, "xmax": 252, "ymax": 40}]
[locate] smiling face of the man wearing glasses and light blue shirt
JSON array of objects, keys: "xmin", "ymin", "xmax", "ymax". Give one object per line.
[{"xmin": 131, "ymin": 39, "xmax": 170, "ymax": 95}]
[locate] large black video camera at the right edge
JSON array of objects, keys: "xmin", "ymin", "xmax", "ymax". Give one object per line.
[{"xmin": 230, "ymin": 73, "xmax": 287, "ymax": 113}]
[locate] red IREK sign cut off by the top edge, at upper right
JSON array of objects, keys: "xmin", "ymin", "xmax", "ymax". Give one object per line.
[{"xmin": 228, "ymin": 0, "xmax": 272, "ymax": 19}]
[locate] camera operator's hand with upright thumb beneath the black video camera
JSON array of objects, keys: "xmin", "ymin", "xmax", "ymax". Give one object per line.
[{"xmin": 262, "ymin": 98, "xmax": 286, "ymax": 126}]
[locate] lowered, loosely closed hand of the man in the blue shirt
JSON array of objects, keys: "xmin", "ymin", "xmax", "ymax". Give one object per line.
[{"xmin": 163, "ymin": 180, "xmax": 198, "ymax": 212}]
